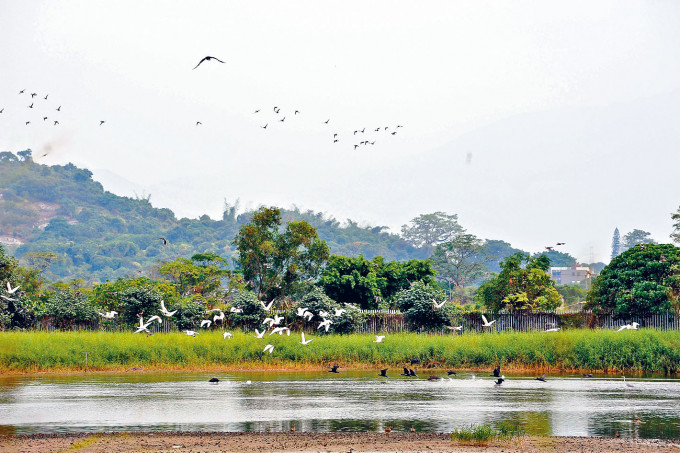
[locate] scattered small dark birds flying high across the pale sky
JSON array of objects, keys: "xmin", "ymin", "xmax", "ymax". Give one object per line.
[{"xmin": 0, "ymin": 56, "xmax": 403, "ymax": 150}]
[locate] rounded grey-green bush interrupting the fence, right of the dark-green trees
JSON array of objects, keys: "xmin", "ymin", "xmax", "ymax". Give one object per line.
[{"xmin": 397, "ymin": 282, "xmax": 454, "ymax": 330}]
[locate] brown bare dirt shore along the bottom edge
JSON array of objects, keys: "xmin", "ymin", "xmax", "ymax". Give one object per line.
[{"xmin": 0, "ymin": 433, "xmax": 680, "ymax": 453}]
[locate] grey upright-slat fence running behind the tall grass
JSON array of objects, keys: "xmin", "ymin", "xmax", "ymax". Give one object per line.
[{"xmin": 35, "ymin": 310, "xmax": 680, "ymax": 333}]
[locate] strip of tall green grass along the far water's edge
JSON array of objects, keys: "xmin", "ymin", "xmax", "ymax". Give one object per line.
[{"xmin": 0, "ymin": 329, "xmax": 680, "ymax": 373}]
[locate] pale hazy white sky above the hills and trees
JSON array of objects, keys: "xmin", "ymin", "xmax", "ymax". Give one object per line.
[{"xmin": 0, "ymin": 0, "xmax": 680, "ymax": 262}]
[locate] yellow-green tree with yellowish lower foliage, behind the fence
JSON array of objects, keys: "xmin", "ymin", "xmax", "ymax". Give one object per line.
[{"xmin": 475, "ymin": 253, "xmax": 560, "ymax": 311}]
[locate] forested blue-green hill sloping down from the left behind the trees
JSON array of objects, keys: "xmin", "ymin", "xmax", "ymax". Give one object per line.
[{"xmin": 0, "ymin": 150, "xmax": 429, "ymax": 281}]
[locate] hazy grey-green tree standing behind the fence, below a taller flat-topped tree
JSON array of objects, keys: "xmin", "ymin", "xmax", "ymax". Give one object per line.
[{"xmin": 430, "ymin": 233, "xmax": 488, "ymax": 286}]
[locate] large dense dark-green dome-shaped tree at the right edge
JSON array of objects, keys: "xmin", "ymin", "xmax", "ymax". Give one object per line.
[{"xmin": 586, "ymin": 244, "xmax": 680, "ymax": 318}]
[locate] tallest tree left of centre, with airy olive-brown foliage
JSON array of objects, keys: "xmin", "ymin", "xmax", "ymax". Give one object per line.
[{"xmin": 234, "ymin": 207, "xmax": 329, "ymax": 300}]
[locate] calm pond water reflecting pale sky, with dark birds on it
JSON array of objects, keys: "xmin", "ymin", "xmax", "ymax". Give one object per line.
[{"xmin": 0, "ymin": 369, "xmax": 680, "ymax": 439}]
